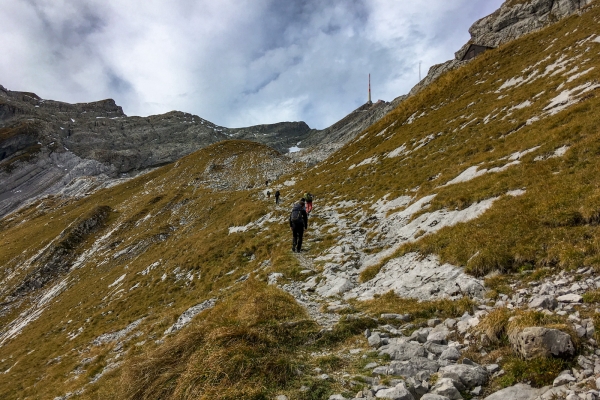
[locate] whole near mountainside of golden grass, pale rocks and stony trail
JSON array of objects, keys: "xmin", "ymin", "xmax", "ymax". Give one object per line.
[{"xmin": 0, "ymin": 0, "xmax": 600, "ymax": 400}]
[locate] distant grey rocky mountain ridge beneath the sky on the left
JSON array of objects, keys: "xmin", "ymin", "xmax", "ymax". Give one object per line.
[{"xmin": 0, "ymin": 86, "xmax": 390, "ymax": 216}]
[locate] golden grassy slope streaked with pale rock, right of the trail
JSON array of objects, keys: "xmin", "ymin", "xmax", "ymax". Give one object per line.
[{"xmin": 299, "ymin": 2, "xmax": 600, "ymax": 275}]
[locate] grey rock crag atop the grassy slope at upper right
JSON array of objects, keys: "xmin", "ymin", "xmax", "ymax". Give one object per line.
[{"xmin": 409, "ymin": 0, "xmax": 593, "ymax": 95}]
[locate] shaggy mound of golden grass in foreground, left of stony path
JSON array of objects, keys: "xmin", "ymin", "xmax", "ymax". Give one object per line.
[{"xmin": 120, "ymin": 281, "xmax": 315, "ymax": 399}]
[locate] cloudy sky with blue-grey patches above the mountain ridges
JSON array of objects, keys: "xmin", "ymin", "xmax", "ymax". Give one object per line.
[{"xmin": 0, "ymin": 0, "xmax": 503, "ymax": 129}]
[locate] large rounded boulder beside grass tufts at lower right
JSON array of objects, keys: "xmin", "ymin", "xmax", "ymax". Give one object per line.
[{"xmin": 509, "ymin": 327, "xmax": 575, "ymax": 359}]
